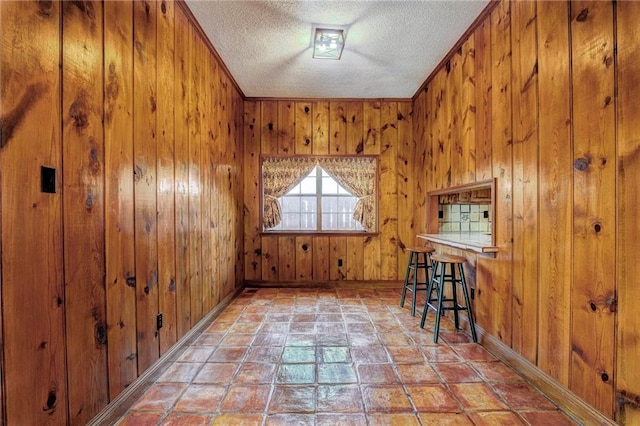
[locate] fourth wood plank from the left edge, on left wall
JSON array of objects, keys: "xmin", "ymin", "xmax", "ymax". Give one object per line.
[{"xmin": 133, "ymin": 2, "xmax": 160, "ymax": 372}]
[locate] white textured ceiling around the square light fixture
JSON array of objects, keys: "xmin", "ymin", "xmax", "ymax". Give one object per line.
[{"xmin": 186, "ymin": 0, "xmax": 488, "ymax": 98}]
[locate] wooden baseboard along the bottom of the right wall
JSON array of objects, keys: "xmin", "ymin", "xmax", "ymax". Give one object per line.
[{"xmin": 476, "ymin": 325, "xmax": 617, "ymax": 426}]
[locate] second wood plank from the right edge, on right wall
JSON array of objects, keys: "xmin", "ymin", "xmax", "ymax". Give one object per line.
[{"xmin": 569, "ymin": 1, "xmax": 616, "ymax": 416}]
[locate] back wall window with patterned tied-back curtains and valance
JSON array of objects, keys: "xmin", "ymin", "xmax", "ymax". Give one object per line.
[{"xmin": 262, "ymin": 156, "xmax": 377, "ymax": 232}]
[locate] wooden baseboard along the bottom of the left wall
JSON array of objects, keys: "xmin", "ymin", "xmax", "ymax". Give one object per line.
[{"xmin": 87, "ymin": 286, "xmax": 245, "ymax": 426}]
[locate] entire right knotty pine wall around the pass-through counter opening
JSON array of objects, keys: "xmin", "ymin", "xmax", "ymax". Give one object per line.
[{"xmin": 413, "ymin": 1, "xmax": 640, "ymax": 424}]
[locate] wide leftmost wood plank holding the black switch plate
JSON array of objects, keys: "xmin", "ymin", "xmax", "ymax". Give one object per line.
[{"xmin": 0, "ymin": 2, "xmax": 67, "ymax": 424}]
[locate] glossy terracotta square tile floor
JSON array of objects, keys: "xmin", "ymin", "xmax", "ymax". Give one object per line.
[{"xmin": 114, "ymin": 288, "xmax": 573, "ymax": 426}]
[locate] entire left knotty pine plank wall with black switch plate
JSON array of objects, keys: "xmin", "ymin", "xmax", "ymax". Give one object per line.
[{"xmin": 0, "ymin": 1, "xmax": 243, "ymax": 424}]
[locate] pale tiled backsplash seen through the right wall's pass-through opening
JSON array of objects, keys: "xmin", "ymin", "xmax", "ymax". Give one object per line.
[{"xmin": 438, "ymin": 204, "xmax": 492, "ymax": 232}]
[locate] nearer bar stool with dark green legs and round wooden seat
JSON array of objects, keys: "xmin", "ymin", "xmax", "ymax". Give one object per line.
[{"xmin": 420, "ymin": 254, "xmax": 478, "ymax": 343}]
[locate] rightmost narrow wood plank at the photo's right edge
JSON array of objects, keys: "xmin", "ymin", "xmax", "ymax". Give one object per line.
[{"xmin": 615, "ymin": 2, "xmax": 640, "ymax": 425}]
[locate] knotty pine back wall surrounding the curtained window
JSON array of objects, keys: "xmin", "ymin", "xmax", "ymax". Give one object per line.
[{"xmin": 244, "ymin": 100, "xmax": 416, "ymax": 282}]
